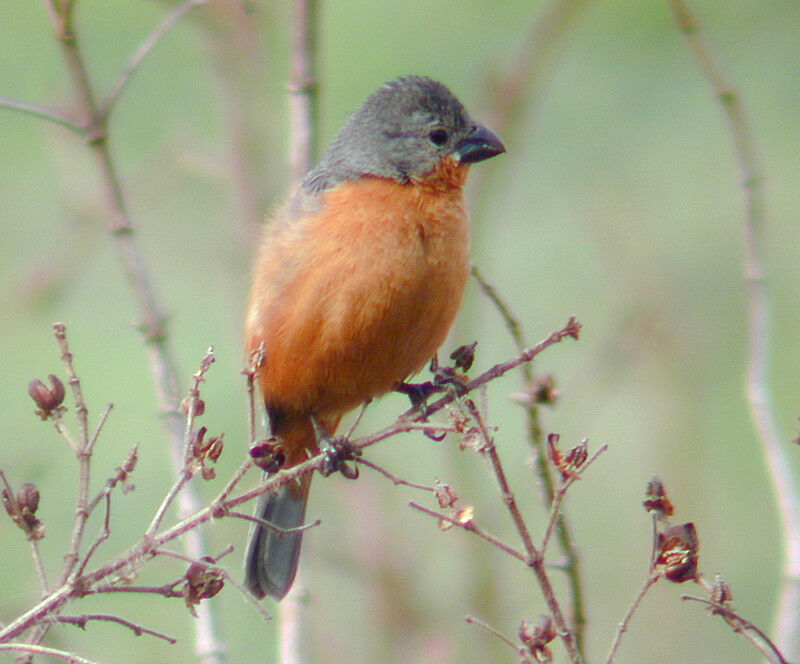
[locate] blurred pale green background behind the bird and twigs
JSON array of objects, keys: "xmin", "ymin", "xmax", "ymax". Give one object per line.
[{"xmin": 0, "ymin": 0, "xmax": 800, "ymax": 664}]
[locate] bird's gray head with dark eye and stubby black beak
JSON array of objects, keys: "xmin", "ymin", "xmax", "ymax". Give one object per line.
[{"xmin": 302, "ymin": 76, "xmax": 505, "ymax": 192}]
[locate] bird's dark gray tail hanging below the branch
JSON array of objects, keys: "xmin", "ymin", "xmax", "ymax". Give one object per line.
[{"xmin": 244, "ymin": 475, "xmax": 311, "ymax": 600}]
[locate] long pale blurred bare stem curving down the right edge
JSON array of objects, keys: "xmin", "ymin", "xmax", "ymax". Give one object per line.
[{"xmin": 668, "ymin": 0, "xmax": 800, "ymax": 659}]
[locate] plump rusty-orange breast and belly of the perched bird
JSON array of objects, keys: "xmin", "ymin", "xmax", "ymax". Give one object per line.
[{"xmin": 247, "ymin": 163, "xmax": 469, "ymax": 416}]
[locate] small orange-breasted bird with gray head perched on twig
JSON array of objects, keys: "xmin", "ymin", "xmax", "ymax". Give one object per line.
[{"xmin": 244, "ymin": 75, "xmax": 505, "ymax": 600}]
